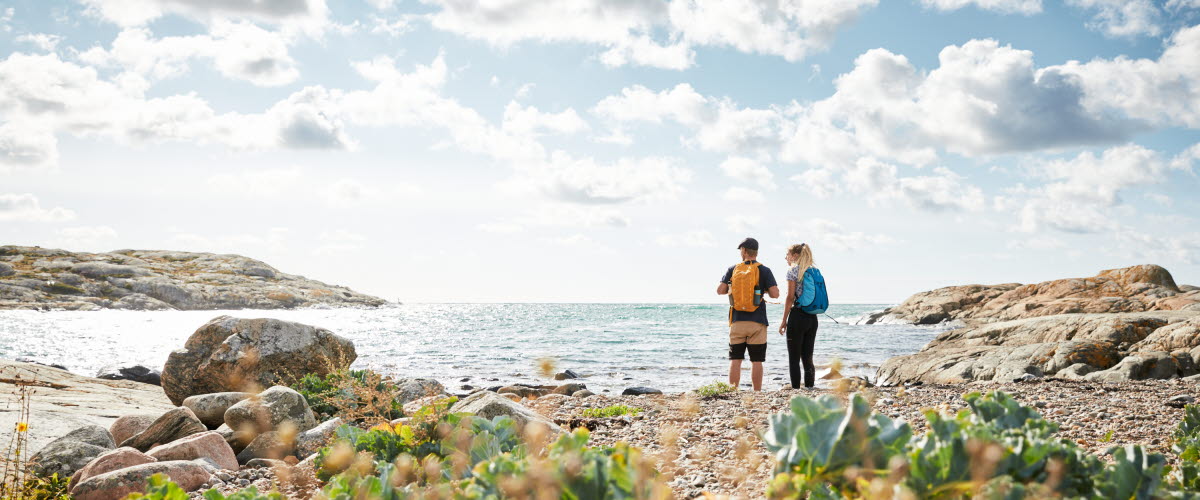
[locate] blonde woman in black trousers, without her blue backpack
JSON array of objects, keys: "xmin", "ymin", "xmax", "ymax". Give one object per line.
[{"xmin": 779, "ymin": 243, "xmax": 817, "ymax": 388}]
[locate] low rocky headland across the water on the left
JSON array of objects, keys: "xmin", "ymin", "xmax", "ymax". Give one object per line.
[{"xmin": 0, "ymin": 246, "xmax": 386, "ymax": 311}]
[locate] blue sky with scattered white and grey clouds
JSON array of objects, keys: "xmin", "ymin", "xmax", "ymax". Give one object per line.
[{"xmin": 0, "ymin": 0, "xmax": 1200, "ymax": 303}]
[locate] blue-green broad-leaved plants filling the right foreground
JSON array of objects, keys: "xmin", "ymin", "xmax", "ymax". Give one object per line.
[{"xmin": 763, "ymin": 392, "xmax": 1200, "ymax": 500}]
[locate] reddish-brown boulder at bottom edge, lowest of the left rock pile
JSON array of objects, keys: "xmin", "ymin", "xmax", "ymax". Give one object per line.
[{"xmin": 71, "ymin": 460, "xmax": 209, "ymax": 500}]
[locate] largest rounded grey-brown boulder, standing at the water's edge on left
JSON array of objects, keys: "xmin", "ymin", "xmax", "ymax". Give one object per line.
[{"xmin": 162, "ymin": 317, "xmax": 358, "ymax": 404}]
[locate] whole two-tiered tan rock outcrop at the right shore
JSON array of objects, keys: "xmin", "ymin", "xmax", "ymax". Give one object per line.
[{"xmin": 870, "ymin": 265, "xmax": 1200, "ymax": 384}]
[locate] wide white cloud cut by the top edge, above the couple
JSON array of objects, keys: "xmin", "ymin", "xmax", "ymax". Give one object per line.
[{"xmin": 425, "ymin": 0, "xmax": 877, "ymax": 70}]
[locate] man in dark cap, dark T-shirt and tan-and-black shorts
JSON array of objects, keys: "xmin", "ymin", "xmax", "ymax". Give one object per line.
[{"xmin": 716, "ymin": 237, "xmax": 779, "ymax": 391}]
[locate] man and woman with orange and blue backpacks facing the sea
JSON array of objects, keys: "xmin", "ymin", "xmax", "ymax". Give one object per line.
[{"xmin": 716, "ymin": 237, "xmax": 829, "ymax": 391}]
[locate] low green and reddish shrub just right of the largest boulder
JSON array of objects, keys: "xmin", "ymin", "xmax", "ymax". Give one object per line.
[{"xmin": 292, "ymin": 369, "xmax": 404, "ymax": 423}]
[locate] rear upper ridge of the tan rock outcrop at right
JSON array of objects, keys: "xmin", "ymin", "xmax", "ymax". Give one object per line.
[{"xmin": 866, "ymin": 264, "xmax": 1200, "ymax": 325}]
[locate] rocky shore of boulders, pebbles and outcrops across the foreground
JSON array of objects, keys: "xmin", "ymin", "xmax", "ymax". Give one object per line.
[{"xmin": 7, "ymin": 262, "xmax": 1200, "ymax": 500}]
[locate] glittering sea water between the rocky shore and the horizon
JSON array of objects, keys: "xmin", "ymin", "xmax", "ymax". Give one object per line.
[{"xmin": 0, "ymin": 303, "xmax": 942, "ymax": 393}]
